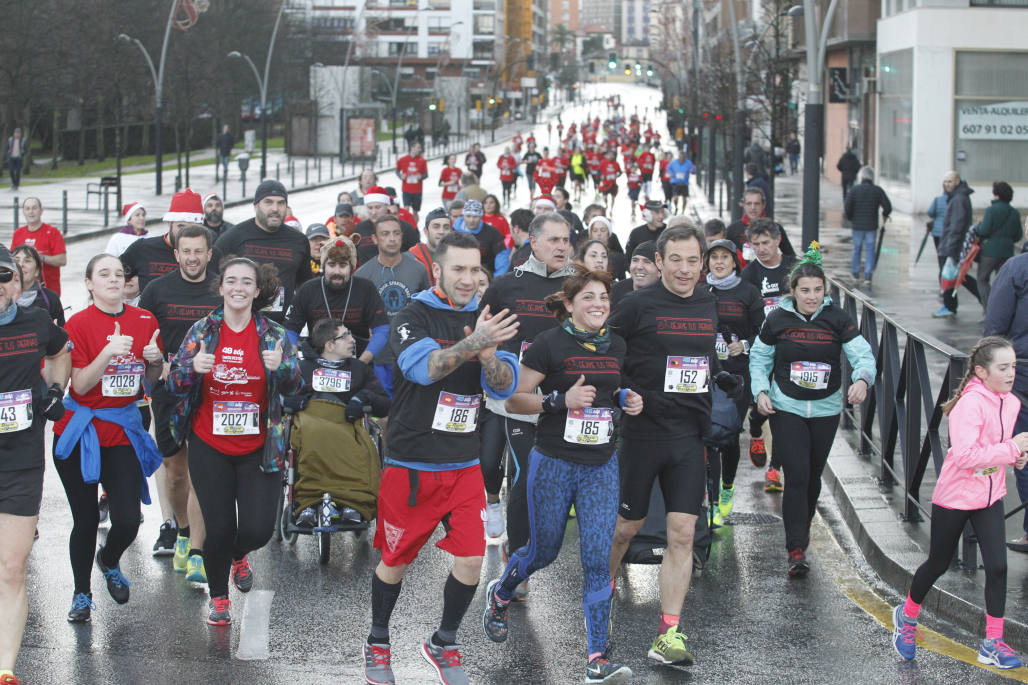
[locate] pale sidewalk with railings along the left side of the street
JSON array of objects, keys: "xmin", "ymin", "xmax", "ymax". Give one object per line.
[{"xmin": 0, "ymin": 118, "xmax": 549, "ymax": 244}]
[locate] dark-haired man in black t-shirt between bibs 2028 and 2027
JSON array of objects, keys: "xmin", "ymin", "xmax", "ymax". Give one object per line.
[{"xmin": 139, "ymin": 224, "xmax": 222, "ymax": 563}]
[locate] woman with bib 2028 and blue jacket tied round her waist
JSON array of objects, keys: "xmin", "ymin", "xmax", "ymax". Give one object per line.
[{"xmin": 53, "ymin": 254, "xmax": 163, "ymax": 623}]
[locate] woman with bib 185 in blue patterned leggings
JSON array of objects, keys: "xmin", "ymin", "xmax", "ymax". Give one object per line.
[{"xmin": 484, "ymin": 263, "xmax": 643, "ymax": 683}]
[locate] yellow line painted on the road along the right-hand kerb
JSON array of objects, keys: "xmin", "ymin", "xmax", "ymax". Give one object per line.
[{"xmin": 810, "ymin": 516, "xmax": 1028, "ymax": 683}]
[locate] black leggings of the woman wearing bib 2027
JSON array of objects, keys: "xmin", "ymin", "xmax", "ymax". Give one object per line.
[{"xmin": 189, "ymin": 433, "xmax": 282, "ymax": 597}]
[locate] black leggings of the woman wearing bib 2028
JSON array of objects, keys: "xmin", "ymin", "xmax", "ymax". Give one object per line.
[{"xmin": 53, "ymin": 436, "xmax": 143, "ymax": 594}]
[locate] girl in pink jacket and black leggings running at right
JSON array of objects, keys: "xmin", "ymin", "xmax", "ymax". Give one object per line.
[{"xmin": 892, "ymin": 335, "xmax": 1028, "ymax": 669}]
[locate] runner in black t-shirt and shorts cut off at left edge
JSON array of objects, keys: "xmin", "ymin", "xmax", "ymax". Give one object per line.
[{"xmin": 0, "ymin": 246, "xmax": 71, "ymax": 677}]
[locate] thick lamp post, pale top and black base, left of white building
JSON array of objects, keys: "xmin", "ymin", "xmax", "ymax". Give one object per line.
[{"xmin": 788, "ymin": 0, "xmax": 839, "ymax": 247}]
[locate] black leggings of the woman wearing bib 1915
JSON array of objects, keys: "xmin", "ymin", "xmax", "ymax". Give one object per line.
[{"xmin": 771, "ymin": 409, "xmax": 839, "ymax": 551}]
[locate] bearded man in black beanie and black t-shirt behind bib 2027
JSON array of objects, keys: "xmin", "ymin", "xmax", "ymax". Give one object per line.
[{"xmin": 215, "ymin": 180, "xmax": 314, "ymax": 324}]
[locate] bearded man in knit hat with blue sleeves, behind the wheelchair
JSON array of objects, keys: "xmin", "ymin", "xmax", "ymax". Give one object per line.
[{"xmin": 285, "ymin": 236, "xmax": 389, "ymax": 364}]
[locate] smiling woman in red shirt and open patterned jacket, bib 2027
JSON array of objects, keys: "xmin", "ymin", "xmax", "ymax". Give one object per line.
[{"xmin": 168, "ymin": 257, "xmax": 303, "ymax": 625}]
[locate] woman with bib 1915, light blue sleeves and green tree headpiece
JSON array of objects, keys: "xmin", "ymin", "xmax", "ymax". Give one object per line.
[{"xmin": 749, "ymin": 242, "xmax": 876, "ymax": 577}]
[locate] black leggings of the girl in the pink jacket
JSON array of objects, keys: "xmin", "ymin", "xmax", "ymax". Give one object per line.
[{"xmin": 910, "ymin": 500, "xmax": 1006, "ymax": 618}]
